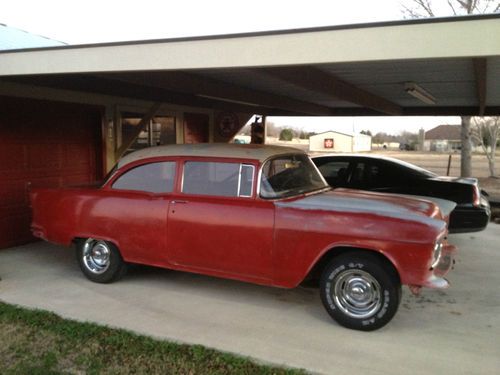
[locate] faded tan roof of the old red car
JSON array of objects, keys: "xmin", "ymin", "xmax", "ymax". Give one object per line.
[{"xmin": 118, "ymin": 143, "xmax": 305, "ymax": 168}]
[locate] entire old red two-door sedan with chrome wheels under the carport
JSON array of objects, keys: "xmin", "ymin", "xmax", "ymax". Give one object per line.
[{"xmin": 31, "ymin": 144, "xmax": 455, "ymax": 331}]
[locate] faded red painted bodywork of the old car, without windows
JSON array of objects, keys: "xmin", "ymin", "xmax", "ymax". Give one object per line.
[{"xmin": 31, "ymin": 151, "xmax": 454, "ymax": 287}]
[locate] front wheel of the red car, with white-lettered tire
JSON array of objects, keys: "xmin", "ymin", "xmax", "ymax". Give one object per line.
[{"xmin": 320, "ymin": 252, "xmax": 401, "ymax": 331}]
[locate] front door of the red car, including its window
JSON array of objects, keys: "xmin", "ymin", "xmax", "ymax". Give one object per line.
[{"xmin": 167, "ymin": 160, "xmax": 274, "ymax": 280}]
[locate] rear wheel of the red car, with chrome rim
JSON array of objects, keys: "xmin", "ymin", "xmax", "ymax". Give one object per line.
[{"xmin": 76, "ymin": 238, "xmax": 127, "ymax": 283}]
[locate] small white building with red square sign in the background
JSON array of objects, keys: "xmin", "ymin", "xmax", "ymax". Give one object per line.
[{"xmin": 309, "ymin": 131, "xmax": 372, "ymax": 152}]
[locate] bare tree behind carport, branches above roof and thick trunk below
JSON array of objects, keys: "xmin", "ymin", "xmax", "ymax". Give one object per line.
[{"xmin": 401, "ymin": 0, "xmax": 500, "ymax": 177}]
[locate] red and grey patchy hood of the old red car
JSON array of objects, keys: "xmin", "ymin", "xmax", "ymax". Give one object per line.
[{"xmin": 276, "ymin": 188, "xmax": 446, "ymax": 227}]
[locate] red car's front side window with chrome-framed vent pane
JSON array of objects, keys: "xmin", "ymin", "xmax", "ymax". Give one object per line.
[{"xmin": 182, "ymin": 161, "xmax": 254, "ymax": 197}]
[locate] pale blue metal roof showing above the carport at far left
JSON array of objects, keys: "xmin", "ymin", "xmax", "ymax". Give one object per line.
[{"xmin": 0, "ymin": 23, "xmax": 65, "ymax": 50}]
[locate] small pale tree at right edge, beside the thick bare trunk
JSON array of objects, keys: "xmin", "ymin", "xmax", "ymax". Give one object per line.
[{"xmin": 471, "ymin": 117, "xmax": 500, "ymax": 177}]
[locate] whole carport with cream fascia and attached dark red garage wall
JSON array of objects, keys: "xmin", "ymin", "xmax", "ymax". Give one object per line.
[{"xmin": 0, "ymin": 15, "xmax": 500, "ymax": 247}]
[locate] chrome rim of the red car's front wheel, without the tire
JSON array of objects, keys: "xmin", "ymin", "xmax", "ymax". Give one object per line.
[{"xmin": 332, "ymin": 270, "xmax": 382, "ymax": 319}]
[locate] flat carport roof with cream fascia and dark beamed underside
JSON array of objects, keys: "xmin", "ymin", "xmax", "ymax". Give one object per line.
[{"xmin": 0, "ymin": 14, "xmax": 500, "ymax": 116}]
